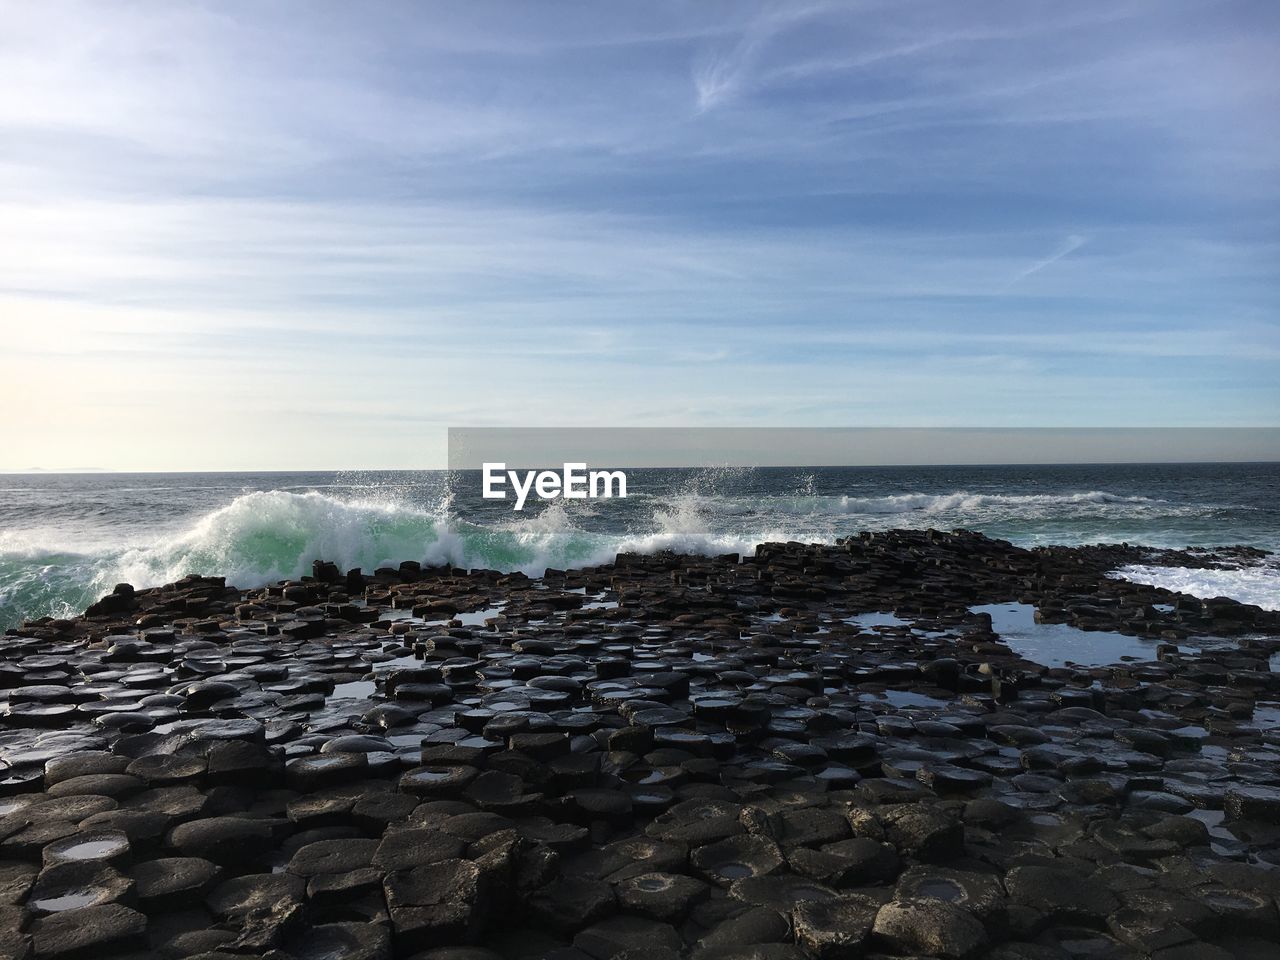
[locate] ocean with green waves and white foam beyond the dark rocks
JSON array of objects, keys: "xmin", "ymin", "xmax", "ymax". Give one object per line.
[{"xmin": 0, "ymin": 463, "xmax": 1280, "ymax": 628}]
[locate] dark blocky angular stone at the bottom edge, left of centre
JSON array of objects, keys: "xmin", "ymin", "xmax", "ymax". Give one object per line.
[{"xmin": 383, "ymin": 860, "xmax": 480, "ymax": 952}]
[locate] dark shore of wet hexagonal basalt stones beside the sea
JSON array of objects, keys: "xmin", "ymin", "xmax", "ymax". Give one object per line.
[{"xmin": 0, "ymin": 531, "xmax": 1280, "ymax": 960}]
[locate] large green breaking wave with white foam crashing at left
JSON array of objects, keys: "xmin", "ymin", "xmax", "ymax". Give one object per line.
[{"xmin": 0, "ymin": 490, "xmax": 782, "ymax": 626}]
